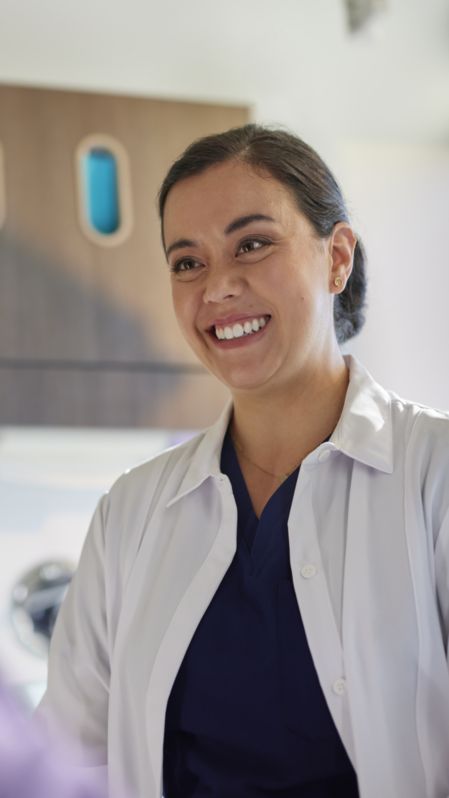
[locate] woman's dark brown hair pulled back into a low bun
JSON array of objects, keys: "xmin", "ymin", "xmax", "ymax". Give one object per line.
[{"xmin": 159, "ymin": 124, "xmax": 366, "ymax": 343}]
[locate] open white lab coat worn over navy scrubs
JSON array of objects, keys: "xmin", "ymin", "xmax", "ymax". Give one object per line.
[{"xmin": 40, "ymin": 357, "xmax": 449, "ymax": 798}]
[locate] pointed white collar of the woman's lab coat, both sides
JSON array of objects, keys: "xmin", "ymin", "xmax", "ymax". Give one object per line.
[{"xmin": 167, "ymin": 355, "xmax": 393, "ymax": 507}]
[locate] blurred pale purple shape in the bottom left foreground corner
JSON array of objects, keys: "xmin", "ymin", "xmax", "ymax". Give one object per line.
[{"xmin": 0, "ymin": 681, "xmax": 107, "ymax": 798}]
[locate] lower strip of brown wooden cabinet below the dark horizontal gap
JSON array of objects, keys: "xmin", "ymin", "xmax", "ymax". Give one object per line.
[{"xmin": 0, "ymin": 362, "xmax": 227, "ymax": 430}]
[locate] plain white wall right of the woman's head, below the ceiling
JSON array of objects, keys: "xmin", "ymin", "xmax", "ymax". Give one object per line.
[{"xmin": 341, "ymin": 141, "xmax": 449, "ymax": 410}]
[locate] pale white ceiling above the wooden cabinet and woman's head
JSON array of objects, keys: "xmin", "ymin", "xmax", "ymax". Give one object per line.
[{"xmin": 0, "ymin": 0, "xmax": 449, "ymax": 150}]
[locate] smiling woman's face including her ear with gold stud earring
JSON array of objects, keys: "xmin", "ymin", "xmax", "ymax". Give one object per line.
[{"xmin": 163, "ymin": 161, "xmax": 352, "ymax": 393}]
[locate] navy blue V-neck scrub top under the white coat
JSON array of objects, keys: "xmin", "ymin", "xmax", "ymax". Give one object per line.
[{"xmin": 164, "ymin": 433, "xmax": 358, "ymax": 798}]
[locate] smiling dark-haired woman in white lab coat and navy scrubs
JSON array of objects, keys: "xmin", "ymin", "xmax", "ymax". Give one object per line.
[{"xmin": 42, "ymin": 125, "xmax": 449, "ymax": 798}]
